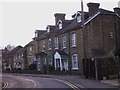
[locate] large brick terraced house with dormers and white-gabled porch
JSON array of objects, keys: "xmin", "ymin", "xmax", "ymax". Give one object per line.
[{"xmin": 34, "ymin": 3, "xmax": 120, "ymax": 77}]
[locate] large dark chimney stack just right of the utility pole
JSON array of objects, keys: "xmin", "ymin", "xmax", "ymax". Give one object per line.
[{"xmin": 87, "ymin": 3, "xmax": 100, "ymax": 16}]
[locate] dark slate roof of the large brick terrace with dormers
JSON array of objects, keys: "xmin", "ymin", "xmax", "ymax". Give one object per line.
[{"xmin": 33, "ymin": 8, "xmax": 119, "ymax": 40}]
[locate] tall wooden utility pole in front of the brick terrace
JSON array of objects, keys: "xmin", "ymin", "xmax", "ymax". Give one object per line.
[{"xmin": 81, "ymin": 0, "xmax": 88, "ymax": 78}]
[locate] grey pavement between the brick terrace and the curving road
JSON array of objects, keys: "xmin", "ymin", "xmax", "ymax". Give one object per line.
[{"xmin": 7, "ymin": 74, "xmax": 119, "ymax": 90}]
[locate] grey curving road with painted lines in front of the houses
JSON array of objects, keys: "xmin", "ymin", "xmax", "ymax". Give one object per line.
[{"xmin": 2, "ymin": 74, "xmax": 78, "ymax": 90}]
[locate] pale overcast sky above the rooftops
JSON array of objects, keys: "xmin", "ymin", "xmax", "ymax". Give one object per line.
[{"xmin": 0, "ymin": 0, "xmax": 119, "ymax": 48}]
